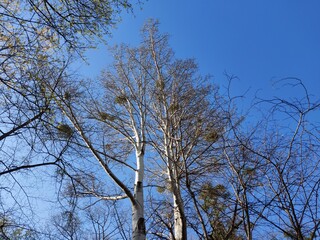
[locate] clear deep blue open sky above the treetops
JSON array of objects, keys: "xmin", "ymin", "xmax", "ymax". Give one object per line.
[{"xmin": 82, "ymin": 0, "xmax": 320, "ymax": 101}]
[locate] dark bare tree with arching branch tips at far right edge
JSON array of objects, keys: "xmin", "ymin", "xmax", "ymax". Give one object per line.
[{"xmin": 255, "ymin": 79, "xmax": 320, "ymax": 240}]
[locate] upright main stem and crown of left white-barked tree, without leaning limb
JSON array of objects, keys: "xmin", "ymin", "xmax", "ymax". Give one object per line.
[{"xmin": 98, "ymin": 43, "xmax": 150, "ymax": 239}]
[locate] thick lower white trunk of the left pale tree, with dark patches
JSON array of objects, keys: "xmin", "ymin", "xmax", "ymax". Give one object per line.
[{"xmin": 132, "ymin": 149, "xmax": 146, "ymax": 240}]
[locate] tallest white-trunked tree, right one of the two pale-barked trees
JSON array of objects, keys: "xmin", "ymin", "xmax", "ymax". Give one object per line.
[{"xmin": 144, "ymin": 21, "xmax": 230, "ymax": 239}]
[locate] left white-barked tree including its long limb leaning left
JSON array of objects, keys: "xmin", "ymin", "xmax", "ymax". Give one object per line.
[{"xmin": 47, "ymin": 36, "xmax": 150, "ymax": 239}]
